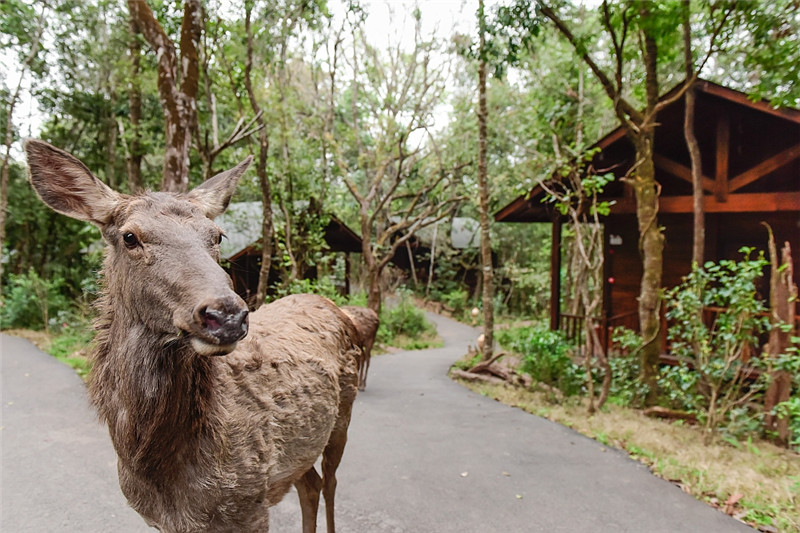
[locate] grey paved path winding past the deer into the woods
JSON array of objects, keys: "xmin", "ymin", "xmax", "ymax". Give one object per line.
[{"xmin": 0, "ymin": 315, "xmax": 752, "ymax": 533}]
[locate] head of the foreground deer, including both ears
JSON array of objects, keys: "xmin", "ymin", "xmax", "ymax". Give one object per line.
[{"xmin": 25, "ymin": 140, "xmax": 252, "ymax": 355}]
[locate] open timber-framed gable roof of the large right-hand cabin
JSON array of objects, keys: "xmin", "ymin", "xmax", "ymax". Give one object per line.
[{"xmin": 495, "ymin": 80, "xmax": 800, "ymax": 222}]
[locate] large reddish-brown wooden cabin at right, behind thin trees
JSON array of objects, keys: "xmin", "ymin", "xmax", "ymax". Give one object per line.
[{"xmin": 495, "ymin": 80, "xmax": 800, "ymax": 344}]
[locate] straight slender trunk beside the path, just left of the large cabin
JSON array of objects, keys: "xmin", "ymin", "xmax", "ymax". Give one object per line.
[{"xmin": 478, "ymin": 0, "xmax": 494, "ymax": 360}]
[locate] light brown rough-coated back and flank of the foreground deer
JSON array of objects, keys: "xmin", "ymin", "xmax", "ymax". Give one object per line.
[{"xmin": 217, "ymin": 294, "xmax": 358, "ymax": 504}]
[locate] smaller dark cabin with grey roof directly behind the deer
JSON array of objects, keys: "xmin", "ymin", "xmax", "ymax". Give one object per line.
[{"xmin": 216, "ymin": 202, "xmax": 361, "ymax": 301}]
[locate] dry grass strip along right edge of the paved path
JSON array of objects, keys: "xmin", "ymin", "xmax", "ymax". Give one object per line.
[{"xmin": 459, "ymin": 374, "xmax": 800, "ymax": 532}]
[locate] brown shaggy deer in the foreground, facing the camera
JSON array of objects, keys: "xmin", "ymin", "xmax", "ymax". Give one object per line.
[{"xmin": 25, "ymin": 140, "xmax": 360, "ymax": 533}]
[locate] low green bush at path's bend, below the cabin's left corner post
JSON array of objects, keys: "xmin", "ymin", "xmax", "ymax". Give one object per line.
[{"xmin": 496, "ymin": 325, "xmax": 585, "ymax": 396}]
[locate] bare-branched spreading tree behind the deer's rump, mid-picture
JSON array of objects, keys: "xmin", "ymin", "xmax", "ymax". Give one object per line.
[{"xmin": 332, "ymin": 15, "xmax": 464, "ymax": 312}]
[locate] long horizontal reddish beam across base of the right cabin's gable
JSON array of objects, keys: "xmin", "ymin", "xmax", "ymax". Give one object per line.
[{"xmin": 607, "ymin": 192, "xmax": 800, "ymax": 216}]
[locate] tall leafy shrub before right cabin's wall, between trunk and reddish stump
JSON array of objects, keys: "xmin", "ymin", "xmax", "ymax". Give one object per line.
[{"xmin": 659, "ymin": 248, "xmax": 769, "ymax": 439}]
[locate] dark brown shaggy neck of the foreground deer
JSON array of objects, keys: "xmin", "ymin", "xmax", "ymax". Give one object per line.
[{"xmin": 89, "ymin": 304, "xmax": 218, "ymax": 479}]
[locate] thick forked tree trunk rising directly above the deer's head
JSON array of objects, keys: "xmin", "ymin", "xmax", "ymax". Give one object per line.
[{"xmin": 128, "ymin": 0, "xmax": 202, "ymax": 192}]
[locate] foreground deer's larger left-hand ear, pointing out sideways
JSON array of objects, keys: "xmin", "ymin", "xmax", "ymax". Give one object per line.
[{"xmin": 25, "ymin": 139, "xmax": 120, "ymax": 226}]
